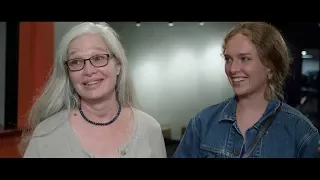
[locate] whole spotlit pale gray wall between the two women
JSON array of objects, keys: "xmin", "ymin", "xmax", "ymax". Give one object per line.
[{"xmin": 123, "ymin": 23, "xmax": 238, "ymax": 139}]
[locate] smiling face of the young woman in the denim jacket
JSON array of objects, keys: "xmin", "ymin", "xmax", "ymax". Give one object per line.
[{"xmin": 224, "ymin": 34, "xmax": 269, "ymax": 96}]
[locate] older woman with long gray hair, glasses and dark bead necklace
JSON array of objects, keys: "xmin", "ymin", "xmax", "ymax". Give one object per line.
[{"xmin": 21, "ymin": 22, "xmax": 166, "ymax": 158}]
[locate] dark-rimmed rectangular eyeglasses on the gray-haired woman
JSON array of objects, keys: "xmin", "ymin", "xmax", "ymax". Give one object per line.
[{"xmin": 65, "ymin": 54, "xmax": 114, "ymax": 71}]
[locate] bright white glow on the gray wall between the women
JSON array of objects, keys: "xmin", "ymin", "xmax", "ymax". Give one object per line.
[{"xmin": 132, "ymin": 45, "xmax": 233, "ymax": 139}]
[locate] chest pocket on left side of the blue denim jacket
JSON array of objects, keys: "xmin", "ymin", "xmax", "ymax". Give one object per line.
[{"xmin": 199, "ymin": 144, "xmax": 234, "ymax": 158}]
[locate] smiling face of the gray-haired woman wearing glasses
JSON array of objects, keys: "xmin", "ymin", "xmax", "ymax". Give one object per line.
[{"xmin": 68, "ymin": 34, "xmax": 120, "ymax": 100}]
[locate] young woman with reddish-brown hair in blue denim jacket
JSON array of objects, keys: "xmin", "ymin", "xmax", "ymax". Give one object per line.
[{"xmin": 174, "ymin": 22, "xmax": 320, "ymax": 158}]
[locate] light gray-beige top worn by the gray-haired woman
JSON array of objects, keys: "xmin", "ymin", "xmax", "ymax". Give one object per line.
[{"xmin": 24, "ymin": 108, "xmax": 167, "ymax": 158}]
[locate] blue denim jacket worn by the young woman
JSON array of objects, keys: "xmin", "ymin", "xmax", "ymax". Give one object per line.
[{"xmin": 173, "ymin": 96, "xmax": 320, "ymax": 158}]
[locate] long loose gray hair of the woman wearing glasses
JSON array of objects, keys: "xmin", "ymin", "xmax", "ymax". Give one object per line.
[{"xmin": 19, "ymin": 22, "xmax": 134, "ymax": 154}]
